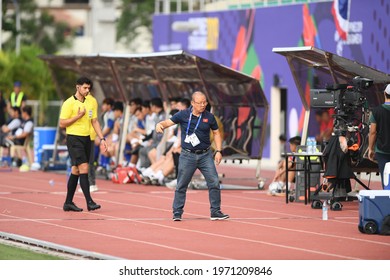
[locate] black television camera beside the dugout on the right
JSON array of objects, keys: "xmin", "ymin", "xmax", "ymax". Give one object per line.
[{"xmin": 310, "ymin": 76, "xmax": 373, "ymax": 165}]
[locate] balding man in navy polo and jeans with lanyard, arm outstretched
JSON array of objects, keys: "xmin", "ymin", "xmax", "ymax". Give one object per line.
[{"xmin": 156, "ymin": 91, "xmax": 229, "ymax": 221}]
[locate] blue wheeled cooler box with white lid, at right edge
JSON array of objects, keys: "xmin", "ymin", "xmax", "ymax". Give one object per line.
[{"xmin": 358, "ymin": 190, "xmax": 390, "ymax": 234}]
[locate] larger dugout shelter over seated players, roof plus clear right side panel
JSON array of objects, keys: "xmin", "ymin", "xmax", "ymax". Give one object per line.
[{"xmin": 40, "ymin": 51, "xmax": 268, "ymax": 159}]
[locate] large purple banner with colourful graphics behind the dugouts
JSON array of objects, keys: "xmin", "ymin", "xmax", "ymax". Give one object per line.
[{"xmin": 153, "ymin": 0, "xmax": 390, "ymax": 158}]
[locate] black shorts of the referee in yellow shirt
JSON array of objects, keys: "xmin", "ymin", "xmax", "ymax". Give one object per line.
[{"xmin": 66, "ymin": 134, "xmax": 91, "ymax": 166}]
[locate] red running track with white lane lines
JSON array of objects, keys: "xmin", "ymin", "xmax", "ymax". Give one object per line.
[{"xmin": 0, "ymin": 165, "xmax": 390, "ymax": 260}]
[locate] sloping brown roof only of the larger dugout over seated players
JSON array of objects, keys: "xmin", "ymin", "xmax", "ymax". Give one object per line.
[{"xmin": 40, "ymin": 51, "xmax": 268, "ymax": 107}]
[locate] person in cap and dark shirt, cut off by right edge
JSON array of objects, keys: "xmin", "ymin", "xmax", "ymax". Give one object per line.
[{"xmin": 368, "ymin": 84, "xmax": 390, "ymax": 188}]
